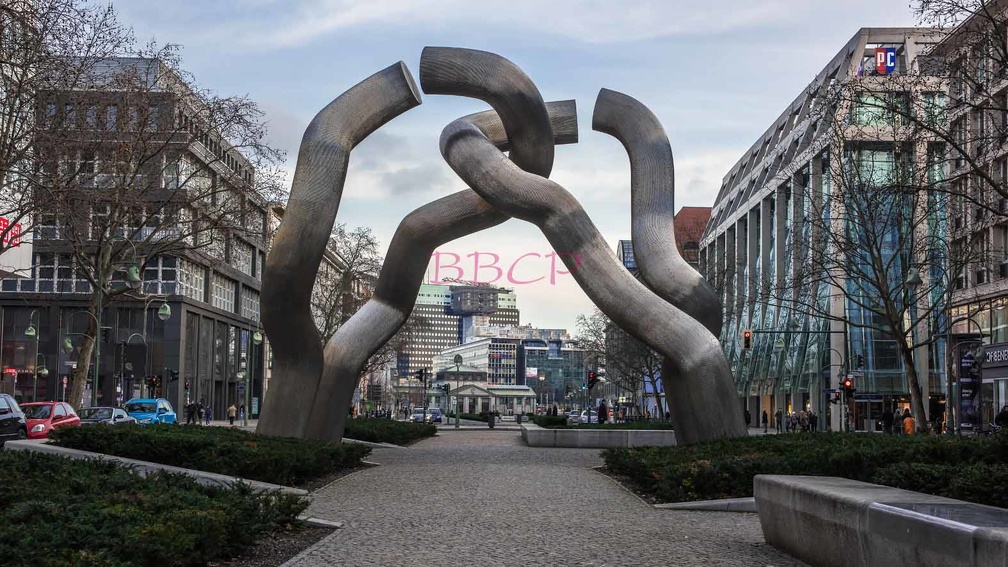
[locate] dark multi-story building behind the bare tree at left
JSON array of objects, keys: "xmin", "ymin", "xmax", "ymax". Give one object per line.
[{"xmin": 0, "ymin": 58, "xmax": 269, "ymax": 417}]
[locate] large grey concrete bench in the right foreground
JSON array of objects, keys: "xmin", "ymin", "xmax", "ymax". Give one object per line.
[{"xmin": 753, "ymin": 474, "xmax": 1008, "ymax": 567}]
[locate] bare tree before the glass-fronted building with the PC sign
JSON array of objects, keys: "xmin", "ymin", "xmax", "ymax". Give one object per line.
[{"xmin": 778, "ymin": 67, "xmax": 992, "ymax": 427}]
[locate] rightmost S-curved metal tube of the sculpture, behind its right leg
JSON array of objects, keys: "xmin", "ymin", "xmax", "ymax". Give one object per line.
[{"xmin": 592, "ymin": 89, "xmax": 722, "ymax": 337}]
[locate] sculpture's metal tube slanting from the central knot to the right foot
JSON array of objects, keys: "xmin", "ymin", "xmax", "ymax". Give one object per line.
[{"xmin": 440, "ymin": 120, "xmax": 746, "ymax": 443}]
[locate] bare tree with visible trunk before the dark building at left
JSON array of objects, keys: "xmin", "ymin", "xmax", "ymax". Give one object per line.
[{"xmin": 29, "ymin": 25, "xmax": 282, "ymax": 401}]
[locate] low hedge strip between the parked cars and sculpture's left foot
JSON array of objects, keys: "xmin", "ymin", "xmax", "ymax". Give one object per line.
[{"xmin": 49, "ymin": 424, "xmax": 371, "ymax": 486}]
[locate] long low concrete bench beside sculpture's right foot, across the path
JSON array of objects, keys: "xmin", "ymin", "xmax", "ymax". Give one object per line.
[{"xmin": 521, "ymin": 424, "xmax": 675, "ymax": 449}]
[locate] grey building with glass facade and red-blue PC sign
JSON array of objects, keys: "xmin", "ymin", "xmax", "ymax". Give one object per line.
[{"xmin": 700, "ymin": 28, "xmax": 944, "ymax": 429}]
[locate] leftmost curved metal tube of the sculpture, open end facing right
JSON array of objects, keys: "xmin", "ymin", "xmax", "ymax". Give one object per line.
[{"xmin": 256, "ymin": 62, "xmax": 420, "ymax": 437}]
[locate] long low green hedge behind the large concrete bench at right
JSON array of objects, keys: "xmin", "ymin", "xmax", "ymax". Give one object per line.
[{"xmin": 602, "ymin": 432, "xmax": 1008, "ymax": 507}]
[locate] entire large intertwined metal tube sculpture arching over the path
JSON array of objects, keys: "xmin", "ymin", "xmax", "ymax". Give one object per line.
[{"xmin": 258, "ymin": 47, "xmax": 746, "ymax": 443}]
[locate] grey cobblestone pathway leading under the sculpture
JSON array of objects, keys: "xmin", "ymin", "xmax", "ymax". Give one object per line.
[{"xmin": 285, "ymin": 431, "xmax": 803, "ymax": 567}]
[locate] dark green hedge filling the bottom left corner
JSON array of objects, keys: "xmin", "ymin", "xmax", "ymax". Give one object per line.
[{"xmin": 0, "ymin": 449, "xmax": 308, "ymax": 567}]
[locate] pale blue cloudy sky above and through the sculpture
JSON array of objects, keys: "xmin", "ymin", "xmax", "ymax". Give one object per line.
[{"xmin": 115, "ymin": 0, "xmax": 914, "ymax": 333}]
